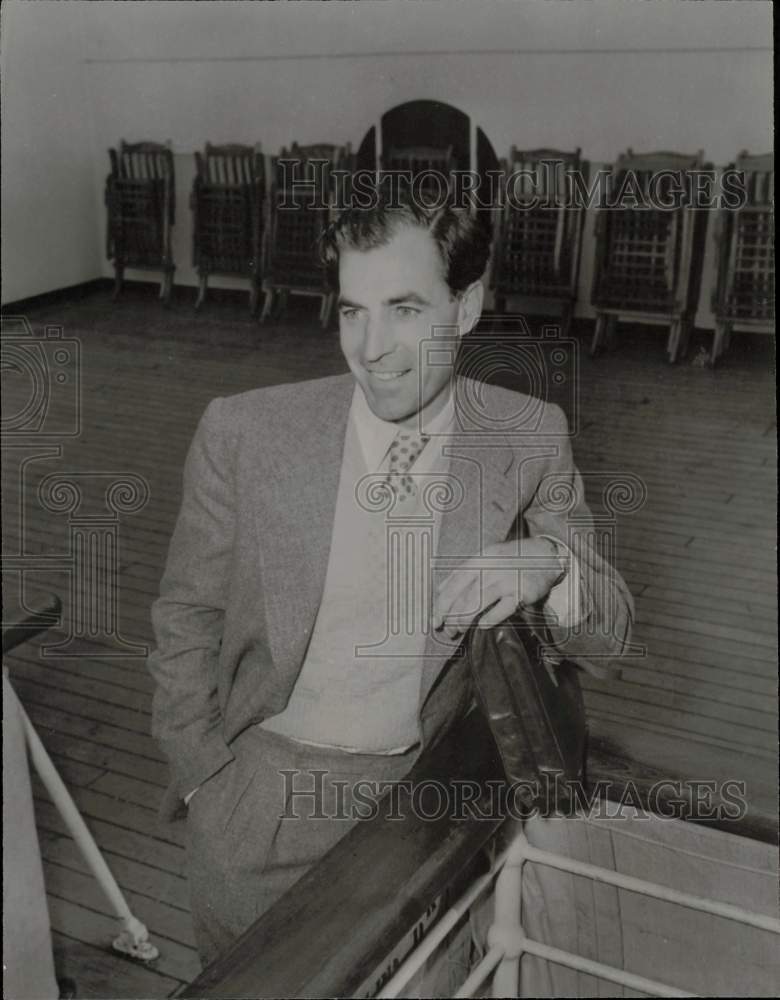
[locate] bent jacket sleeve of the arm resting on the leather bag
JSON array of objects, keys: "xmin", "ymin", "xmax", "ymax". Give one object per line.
[{"xmin": 523, "ymin": 405, "xmax": 634, "ymax": 676}]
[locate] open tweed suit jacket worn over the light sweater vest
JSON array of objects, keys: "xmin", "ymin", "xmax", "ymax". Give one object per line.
[{"xmin": 149, "ymin": 375, "xmax": 633, "ymax": 815}]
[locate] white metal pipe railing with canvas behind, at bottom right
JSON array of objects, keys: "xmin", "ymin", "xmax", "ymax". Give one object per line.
[{"xmin": 378, "ymin": 833, "xmax": 780, "ymax": 998}]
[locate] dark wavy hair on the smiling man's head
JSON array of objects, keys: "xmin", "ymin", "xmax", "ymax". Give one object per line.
[{"xmin": 320, "ymin": 193, "xmax": 491, "ymax": 295}]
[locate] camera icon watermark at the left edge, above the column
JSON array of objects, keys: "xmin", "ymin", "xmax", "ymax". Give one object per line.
[{"xmin": 0, "ymin": 316, "xmax": 82, "ymax": 438}]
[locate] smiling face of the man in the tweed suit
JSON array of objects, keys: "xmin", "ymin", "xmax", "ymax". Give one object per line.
[{"xmin": 339, "ymin": 225, "xmax": 482, "ymax": 427}]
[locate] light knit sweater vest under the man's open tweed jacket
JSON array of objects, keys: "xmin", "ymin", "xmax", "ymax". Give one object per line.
[{"xmin": 262, "ymin": 414, "xmax": 434, "ymax": 753}]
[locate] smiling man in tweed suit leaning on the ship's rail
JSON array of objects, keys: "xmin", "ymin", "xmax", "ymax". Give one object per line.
[{"xmin": 150, "ymin": 191, "xmax": 632, "ymax": 961}]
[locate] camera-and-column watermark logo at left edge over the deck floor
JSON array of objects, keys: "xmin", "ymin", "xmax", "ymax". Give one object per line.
[{"xmin": 0, "ymin": 316, "xmax": 150, "ymax": 659}]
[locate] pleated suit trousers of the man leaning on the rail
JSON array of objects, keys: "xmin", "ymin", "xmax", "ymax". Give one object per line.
[{"xmin": 186, "ymin": 725, "xmax": 417, "ymax": 964}]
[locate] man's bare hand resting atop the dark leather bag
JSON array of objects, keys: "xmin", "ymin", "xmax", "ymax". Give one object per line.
[{"xmin": 433, "ymin": 538, "xmax": 565, "ymax": 639}]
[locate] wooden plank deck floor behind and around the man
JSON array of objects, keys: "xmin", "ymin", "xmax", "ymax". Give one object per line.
[{"xmin": 3, "ymin": 288, "xmax": 777, "ymax": 997}]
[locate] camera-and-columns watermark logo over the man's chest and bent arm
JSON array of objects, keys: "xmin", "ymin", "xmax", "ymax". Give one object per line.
[{"xmin": 355, "ymin": 316, "xmax": 647, "ymax": 660}]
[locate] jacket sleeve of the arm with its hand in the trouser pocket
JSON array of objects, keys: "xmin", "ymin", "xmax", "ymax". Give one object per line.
[{"xmin": 148, "ymin": 399, "xmax": 235, "ymax": 798}]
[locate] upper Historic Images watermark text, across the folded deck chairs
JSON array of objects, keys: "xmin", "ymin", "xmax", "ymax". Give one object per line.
[{"xmin": 277, "ymin": 158, "xmax": 747, "ymax": 212}]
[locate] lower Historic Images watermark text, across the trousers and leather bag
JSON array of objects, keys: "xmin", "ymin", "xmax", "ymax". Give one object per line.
[{"xmin": 279, "ymin": 768, "xmax": 748, "ymax": 823}]
